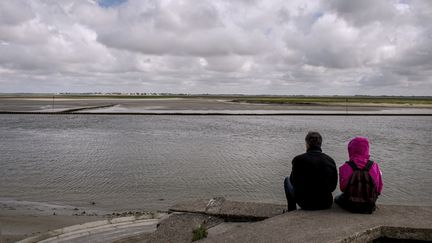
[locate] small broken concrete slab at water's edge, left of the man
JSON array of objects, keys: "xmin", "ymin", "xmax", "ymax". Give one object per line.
[{"xmin": 170, "ymin": 197, "xmax": 286, "ymax": 222}]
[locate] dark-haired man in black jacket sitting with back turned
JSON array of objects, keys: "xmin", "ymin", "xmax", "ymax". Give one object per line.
[{"xmin": 284, "ymin": 132, "xmax": 337, "ymax": 211}]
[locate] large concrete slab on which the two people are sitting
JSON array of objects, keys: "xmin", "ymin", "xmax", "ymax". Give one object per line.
[{"xmin": 200, "ymin": 205, "xmax": 432, "ymax": 243}]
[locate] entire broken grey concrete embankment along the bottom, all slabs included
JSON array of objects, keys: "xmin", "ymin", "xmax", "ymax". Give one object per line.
[{"xmin": 15, "ymin": 198, "xmax": 432, "ymax": 243}]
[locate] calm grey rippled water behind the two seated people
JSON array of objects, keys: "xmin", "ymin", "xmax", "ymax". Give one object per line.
[{"xmin": 0, "ymin": 115, "xmax": 432, "ymax": 210}]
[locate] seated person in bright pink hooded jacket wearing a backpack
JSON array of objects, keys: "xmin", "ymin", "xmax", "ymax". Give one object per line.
[{"xmin": 335, "ymin": 137, "xmax": 383, "ymax": 213}]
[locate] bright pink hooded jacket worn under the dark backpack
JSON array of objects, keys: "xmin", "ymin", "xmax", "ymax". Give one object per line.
[{"xmin": 339, "ymin": 137, "xmax": 383, "ymax": 194}]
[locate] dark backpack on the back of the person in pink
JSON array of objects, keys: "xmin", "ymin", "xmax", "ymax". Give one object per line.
[{"xmin": 344, "ymin": 160, "xmax": 378, "ymax": 214}]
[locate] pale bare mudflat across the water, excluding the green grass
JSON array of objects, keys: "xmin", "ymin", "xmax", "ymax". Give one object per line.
[{"xmin": 0, "ymin": 98, "xmax": 432, "ymax": 113}]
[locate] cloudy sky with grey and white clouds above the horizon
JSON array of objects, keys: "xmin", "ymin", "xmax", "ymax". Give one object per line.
[{"xmin": 0, "ymin": 0, "xmax": 432, "ymax": 95}]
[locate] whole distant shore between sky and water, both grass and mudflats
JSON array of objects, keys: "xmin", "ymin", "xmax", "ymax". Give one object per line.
[{"xmin": 0, "ymin": 95, "xmax": 432, "ymax": 115}]
